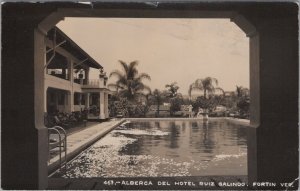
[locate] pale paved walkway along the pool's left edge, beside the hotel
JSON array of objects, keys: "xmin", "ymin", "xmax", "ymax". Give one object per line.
[{"xmin": 48, "ymin": 119, "xmax": 125, "ymax": 172}]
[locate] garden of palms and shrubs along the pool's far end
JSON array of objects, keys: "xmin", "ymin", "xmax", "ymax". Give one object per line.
[{"xmin": 108, "ymin": 60, "xmax": 250, "ymax": 119}]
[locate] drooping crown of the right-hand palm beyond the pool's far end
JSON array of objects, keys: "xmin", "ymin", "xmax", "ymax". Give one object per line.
[{"xmin": 188, "ymin": 77, "xmax": 221, "ymax": 99}]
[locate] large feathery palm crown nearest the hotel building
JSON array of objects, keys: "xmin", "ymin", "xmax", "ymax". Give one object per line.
[{"xmin": 108, "ymin": 60, "xmax": 151, "ymax": 101}]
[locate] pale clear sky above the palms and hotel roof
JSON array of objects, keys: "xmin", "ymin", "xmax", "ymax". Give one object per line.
[{"xmin": 57, "ymin": 18, "xmax": 249, "ymax": 95}]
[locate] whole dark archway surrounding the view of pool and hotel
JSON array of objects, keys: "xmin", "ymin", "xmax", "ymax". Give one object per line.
[{"xmin": 1, "ymin": 0, "xmax": 299, "ymax": 189}]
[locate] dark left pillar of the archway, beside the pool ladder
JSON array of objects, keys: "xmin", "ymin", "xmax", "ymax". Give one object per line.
[{"xmin": 1, "ymin": 22, "xmax": 48, "ymax": 190}]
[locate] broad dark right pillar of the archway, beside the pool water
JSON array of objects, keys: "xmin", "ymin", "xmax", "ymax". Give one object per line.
[{"xmin": 248, "ymin": 15, "xmax": 299, "ymax": 183}]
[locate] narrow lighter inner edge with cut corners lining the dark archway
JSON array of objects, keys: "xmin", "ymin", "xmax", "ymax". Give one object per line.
[{"xmin": 35, "ymin": 8, "xmax": 260, "ymax": 187}]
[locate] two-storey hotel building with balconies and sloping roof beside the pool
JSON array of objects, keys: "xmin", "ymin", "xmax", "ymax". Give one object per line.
[{"xmin": 44, "ymin": 27, "xmax": 110, "ymax": 119}]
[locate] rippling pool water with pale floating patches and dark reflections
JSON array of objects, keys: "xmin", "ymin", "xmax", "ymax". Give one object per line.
[{"xmin": 54, "ymin": 119, "xmax": 247, "ymax": 178}]
